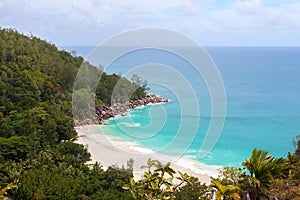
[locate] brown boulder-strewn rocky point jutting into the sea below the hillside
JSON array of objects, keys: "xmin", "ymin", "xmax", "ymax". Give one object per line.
[{"xmin": 75, "ymin": 94, "xmax": 168, "ymax": 126}]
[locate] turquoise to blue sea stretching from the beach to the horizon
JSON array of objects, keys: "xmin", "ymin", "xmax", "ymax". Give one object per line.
[{"xmin": 64, "ymin": 47, "xmax": 300, "ymax": 166}]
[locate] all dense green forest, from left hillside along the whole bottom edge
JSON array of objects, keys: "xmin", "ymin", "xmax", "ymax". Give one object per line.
[{"xmin": 0, "ymin": 29, "xmax": 300, "ymax": 200}]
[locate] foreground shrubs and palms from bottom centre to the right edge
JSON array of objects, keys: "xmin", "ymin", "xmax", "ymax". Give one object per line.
[{"xmin": 123, "ymin": 139, "xmax": 300, "ymax": 200}]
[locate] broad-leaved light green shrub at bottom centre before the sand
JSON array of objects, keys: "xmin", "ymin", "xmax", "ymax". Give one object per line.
[{"xmin": 123, "ymin": 159, "xmax": 207, "ymax": 199}]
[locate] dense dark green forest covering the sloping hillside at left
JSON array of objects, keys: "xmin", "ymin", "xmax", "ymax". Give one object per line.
[{"xmin": 0, "ymin": 29, "xmax": 146, "ymax": 199}]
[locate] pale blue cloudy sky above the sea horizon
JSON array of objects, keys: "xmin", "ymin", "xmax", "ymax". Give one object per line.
[{"xmin": 0, "ymin": 0, "xmax": 300, "ymax": 46}]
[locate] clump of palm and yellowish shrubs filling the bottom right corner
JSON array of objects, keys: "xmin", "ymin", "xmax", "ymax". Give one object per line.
[{"xmin": 212, "ymin": 141, "xmax": 300, "ymax": 200}]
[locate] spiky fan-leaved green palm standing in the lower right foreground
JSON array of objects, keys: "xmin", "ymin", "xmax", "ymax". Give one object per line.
[{"xmin": 242, "ymin": 148, "xmax": 287, "ymax": 198}]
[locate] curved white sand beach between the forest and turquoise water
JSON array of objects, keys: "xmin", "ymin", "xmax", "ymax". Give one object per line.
[{"xmin": 75, "ymin": 125, "xmax": 220, "ymax": 184}]
